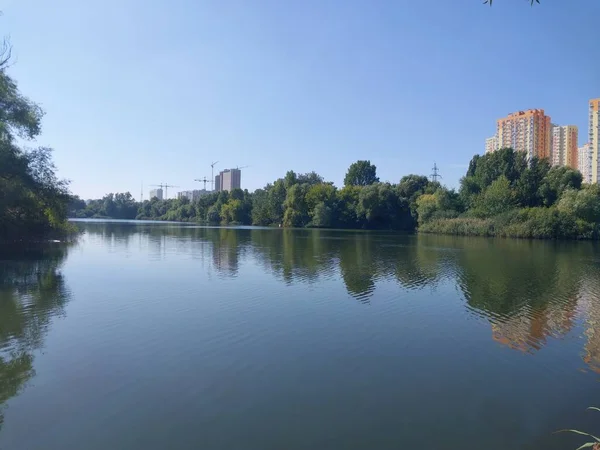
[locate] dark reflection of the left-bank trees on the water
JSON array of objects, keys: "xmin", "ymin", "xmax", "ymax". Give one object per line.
[{"xmin": 0, "ymin": 244, "xmax": 69, "ymax": 429}]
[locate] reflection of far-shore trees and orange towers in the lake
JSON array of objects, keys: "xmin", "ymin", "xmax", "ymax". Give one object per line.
[{"xmin": 78, "ymin": 223, "xmax": 600, "ymax": 372}]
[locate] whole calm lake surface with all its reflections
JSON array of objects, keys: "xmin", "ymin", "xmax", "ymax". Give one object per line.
[{"xmin": 0, "ymin": 223, "xmax": 600, "ymax": 450}]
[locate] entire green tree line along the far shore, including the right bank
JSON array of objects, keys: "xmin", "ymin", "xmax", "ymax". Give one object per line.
[{"xmin": 69, "ymin": 148, "xmax": 600, "ymax": 239}]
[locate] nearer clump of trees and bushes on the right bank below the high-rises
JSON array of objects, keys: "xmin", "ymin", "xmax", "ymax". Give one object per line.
[{"xmin": 416, "ymin": 148, "xmax": 600, "ymax": 239}]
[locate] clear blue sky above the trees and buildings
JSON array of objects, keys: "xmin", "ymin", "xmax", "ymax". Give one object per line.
[{"xmin": 0, "ymin": 0, "xmax": 600, "ymax": 198}]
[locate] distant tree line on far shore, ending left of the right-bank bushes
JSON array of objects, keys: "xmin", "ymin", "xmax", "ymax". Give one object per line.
[{"xmin": 69, "ymin": 161, "xmax": 442, "ymax": 231}]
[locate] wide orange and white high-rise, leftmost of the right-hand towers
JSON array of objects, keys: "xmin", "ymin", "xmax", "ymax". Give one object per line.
[{"xmin": 496, "ymin": 109, "xmax": 552, "ymax": 158}]
